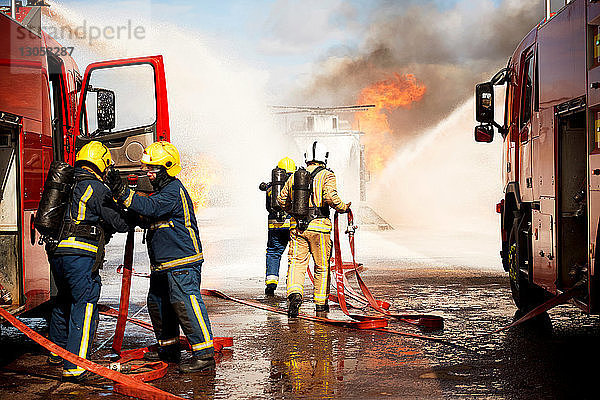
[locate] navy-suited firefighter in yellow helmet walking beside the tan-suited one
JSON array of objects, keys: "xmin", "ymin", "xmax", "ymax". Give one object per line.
[{"xmin": 259, "ymin": 157, "xmax": 296, "ymax": 296}]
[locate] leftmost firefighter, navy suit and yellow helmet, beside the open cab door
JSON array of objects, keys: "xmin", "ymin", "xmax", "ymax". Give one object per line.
[{"xmin": 47, "ymin": 141, "xmax": 129, "ymax": 382}]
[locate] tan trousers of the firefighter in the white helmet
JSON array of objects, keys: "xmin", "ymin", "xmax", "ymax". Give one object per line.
[{"xmin": 287, "ymin": 228, "xmax": 331, "ymax": 305}]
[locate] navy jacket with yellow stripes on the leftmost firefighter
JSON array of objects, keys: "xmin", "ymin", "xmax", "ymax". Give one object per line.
[{"xmin": 54, "ymin": 167, "xmax": 129, "ymax": 257}]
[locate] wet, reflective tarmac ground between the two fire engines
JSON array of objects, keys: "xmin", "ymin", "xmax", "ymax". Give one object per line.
[{"xmin": 0, "ymin": 212, "xmax": 600, "ymax": 400}]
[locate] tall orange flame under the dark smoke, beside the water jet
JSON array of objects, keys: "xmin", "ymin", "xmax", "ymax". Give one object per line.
[{"xmin": 358, "ymin": 73, "xmax": 427, "ymax": 172}]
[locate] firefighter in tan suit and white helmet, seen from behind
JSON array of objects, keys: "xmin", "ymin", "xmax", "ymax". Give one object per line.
[{"xmin": 277, "ymin": 141, "xmax": 350, "ymax": 318}]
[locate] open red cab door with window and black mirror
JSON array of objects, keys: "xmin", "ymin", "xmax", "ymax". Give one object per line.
[{"xmin": 76, "ymin": 56, "xmax": 170, "ymax": 190}]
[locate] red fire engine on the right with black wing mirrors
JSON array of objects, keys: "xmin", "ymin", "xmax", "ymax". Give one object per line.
[{"xmin": 475, "ymin": 0, "xmax": 600, "ymax": 313}]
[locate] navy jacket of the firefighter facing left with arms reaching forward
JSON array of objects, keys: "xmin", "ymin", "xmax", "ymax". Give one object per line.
[{"xmin": 121, "ymin": 178, "xmax": 204, "ymax": 271}]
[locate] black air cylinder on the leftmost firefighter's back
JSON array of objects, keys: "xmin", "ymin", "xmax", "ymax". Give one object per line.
[{"xmin": 34, "ymin": 161, "xmax": 75, "ymax": 239}]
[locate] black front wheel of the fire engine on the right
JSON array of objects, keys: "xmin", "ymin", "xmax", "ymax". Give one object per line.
[{"xmin": 508, "ymin": 224, "xmax": 544, "ymax": 312}]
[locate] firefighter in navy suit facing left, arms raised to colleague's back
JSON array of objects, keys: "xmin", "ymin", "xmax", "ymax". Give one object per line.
[{"xmin": 106, "ymin": 141, "xmax": 215, "ymax": 372}]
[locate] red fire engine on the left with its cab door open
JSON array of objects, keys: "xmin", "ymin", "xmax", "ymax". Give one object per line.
[{"xmin": 0, "ymin": 3, "xmax": 170, "ymax": 314}]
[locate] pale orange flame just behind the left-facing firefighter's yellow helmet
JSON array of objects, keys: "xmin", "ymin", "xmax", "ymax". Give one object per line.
[{"xmin": 179, "ymin": 157, "xmax": 217, "ymax": 212}]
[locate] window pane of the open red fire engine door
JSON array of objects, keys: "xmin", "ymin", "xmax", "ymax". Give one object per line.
[{"xmin": 85, "ymin": 64, "xmax": 156, "ymax": 137}]
